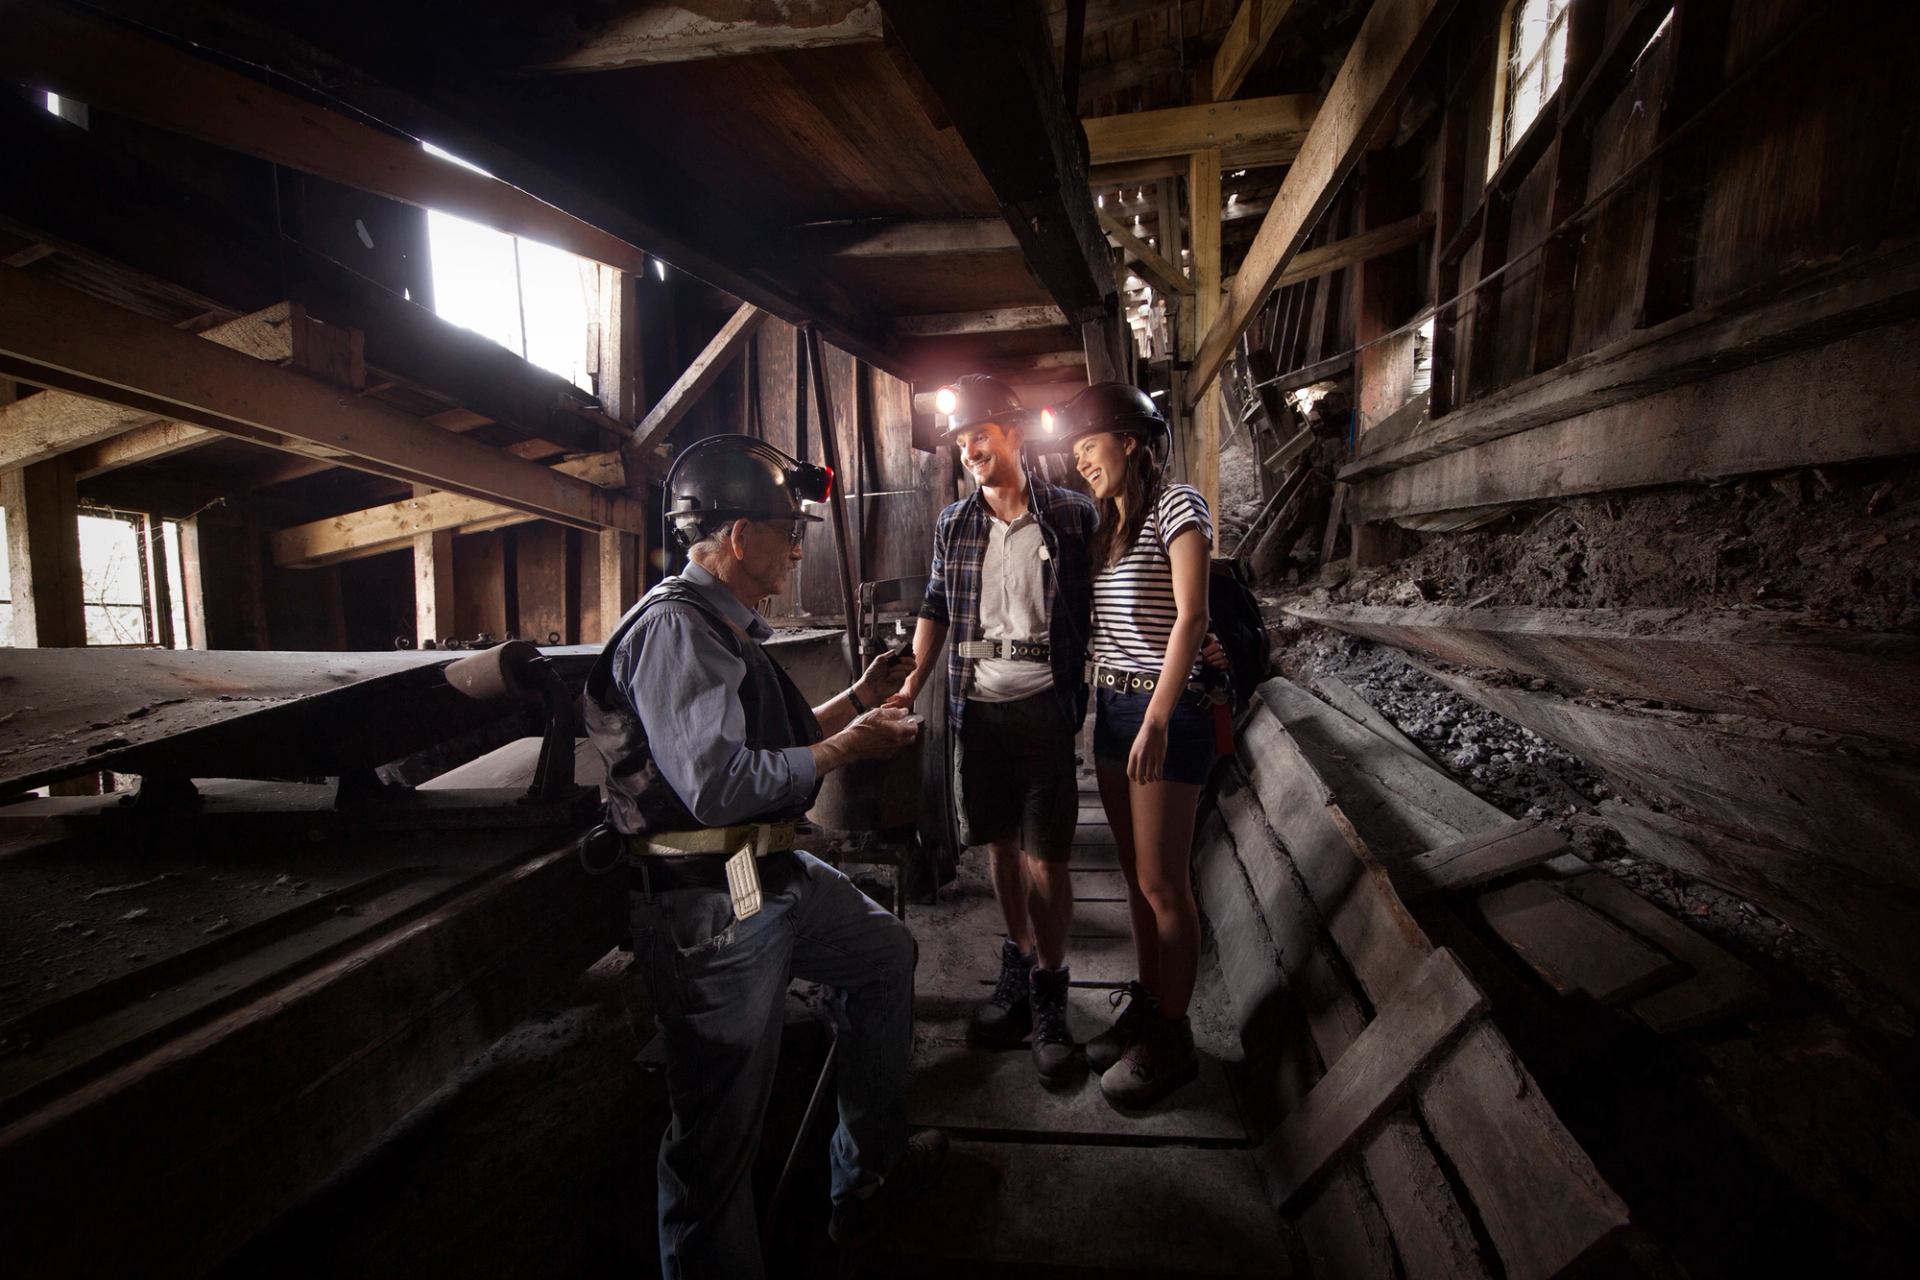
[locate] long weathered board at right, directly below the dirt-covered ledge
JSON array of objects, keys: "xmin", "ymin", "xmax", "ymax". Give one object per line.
[{"xmin": 1286, "ymin": 604, "xmax": 1920, "ymax": 745}]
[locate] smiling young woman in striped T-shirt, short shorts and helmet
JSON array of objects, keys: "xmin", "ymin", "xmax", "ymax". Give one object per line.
[{"xmin": 1062, "ymin": 382, "xmax": 1215, "ymax": 1107}]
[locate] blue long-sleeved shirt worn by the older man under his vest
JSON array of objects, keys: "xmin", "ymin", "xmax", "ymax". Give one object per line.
[{"xmin": 612, "ymin": 560, "xmax": 818, "ymax": 827}]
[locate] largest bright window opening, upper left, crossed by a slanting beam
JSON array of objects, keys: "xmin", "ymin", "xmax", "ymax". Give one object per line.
[{"xmin": 426, "ymin": 146, "xmax": 599, "ymax": 391}]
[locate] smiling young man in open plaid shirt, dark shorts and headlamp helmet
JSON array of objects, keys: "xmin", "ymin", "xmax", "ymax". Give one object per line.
[{"xmin": 889, "ymin": 374, "xmax": 1092, "ymax": 1082}]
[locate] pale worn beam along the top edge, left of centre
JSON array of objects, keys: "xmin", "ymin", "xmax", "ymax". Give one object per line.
[{"xmin": 522, "ymin": 0, "xmax": 881, "ymax": 71}]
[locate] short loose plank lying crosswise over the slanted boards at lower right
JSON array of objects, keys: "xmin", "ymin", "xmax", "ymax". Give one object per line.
[{"xmin": 1265, "ymin": 950, "xmax": 1486, "ymax": 1205}]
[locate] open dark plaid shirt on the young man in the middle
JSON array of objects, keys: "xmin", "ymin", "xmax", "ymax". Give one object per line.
[{"xmin": 920, "ymin": 472, "xmax": 1094, "ymax": 733}]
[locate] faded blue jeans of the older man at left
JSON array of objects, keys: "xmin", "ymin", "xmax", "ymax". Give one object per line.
[{"xmin": 630, "ymin": 852, "xmax": 914, "ymax": 1280}]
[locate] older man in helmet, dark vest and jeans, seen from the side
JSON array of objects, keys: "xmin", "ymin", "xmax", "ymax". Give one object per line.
[{"xmin": 586, "ymin": 436, "xmax": 947, "ymax": 1280}]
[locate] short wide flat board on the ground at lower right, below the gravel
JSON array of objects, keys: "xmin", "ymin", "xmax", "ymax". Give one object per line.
[{"xmin": 1480, "ymin": 881, "xmax": 1680, "ymax": 1004}]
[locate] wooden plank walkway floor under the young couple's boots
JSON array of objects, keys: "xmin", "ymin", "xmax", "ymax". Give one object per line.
[{"xmin": 858, "ymin": 773, "xmax": 1288, "ymax": 1276}]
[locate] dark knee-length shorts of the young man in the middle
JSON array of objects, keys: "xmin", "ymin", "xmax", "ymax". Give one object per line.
[{"xmin": 954, "ymin": 689, "xmax": 1079, "ymax": 862}]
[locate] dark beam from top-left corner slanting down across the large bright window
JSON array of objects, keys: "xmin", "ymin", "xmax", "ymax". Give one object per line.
[{"xmin": 0, "ymin": 0, "xmax": 647, "ymax": 273}]
